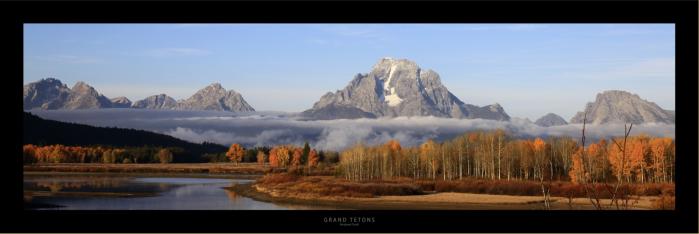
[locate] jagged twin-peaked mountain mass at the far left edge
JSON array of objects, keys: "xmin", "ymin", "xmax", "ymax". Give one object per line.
[{"xmin": 23, "ymin": 78, "xmax": 112, "ymax": 110}]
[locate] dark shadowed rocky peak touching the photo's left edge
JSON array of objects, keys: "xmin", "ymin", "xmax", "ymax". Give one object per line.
[{"xmin": 22, "ymin": 78, "xmax": 71, "ymax": 110}]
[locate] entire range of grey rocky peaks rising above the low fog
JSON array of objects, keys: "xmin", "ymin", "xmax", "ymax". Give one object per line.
[{"xmin": 23, "ymin": 57, "xmax": 675, "ymax": 124}]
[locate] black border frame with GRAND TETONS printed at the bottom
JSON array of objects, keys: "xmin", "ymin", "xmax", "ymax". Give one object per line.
[{"xmin": 0, "ymin": 0, "xmax": 699, "ymax": 233}]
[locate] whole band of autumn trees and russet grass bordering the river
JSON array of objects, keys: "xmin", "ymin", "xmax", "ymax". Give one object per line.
[{"xmin": 23, "ymin": 114, "xmax": 676, "ymax": 210}]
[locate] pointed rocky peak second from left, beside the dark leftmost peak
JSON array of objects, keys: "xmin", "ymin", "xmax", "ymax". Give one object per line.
[{"xmin": 63, "ymin": 81, "xmax": 112, "ymax": 110}]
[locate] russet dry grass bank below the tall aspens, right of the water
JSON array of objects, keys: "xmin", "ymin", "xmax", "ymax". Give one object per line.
[{"xmin": 249, "ymin": 173, "xmax": 674, "ymax": 209}]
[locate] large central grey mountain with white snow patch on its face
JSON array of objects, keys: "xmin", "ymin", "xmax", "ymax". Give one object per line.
[{"xmin": 302, "ymin": 58, "xmax": 510, "ymax": 120}]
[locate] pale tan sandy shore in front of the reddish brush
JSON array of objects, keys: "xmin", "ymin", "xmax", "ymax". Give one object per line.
[{"xmin": 227, "ymin": 184, "xmax": 654, "ymax": 210}]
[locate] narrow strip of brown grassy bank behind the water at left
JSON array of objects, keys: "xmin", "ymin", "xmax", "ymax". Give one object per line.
[{"xmin": 24, "ymin": 163, "xmax": 269, "ymax": 175}]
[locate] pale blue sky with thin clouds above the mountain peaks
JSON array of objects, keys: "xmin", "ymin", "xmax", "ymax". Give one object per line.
[{"xmin": 24, "ymin": 24, "xmax": 675, "ymax": 120}]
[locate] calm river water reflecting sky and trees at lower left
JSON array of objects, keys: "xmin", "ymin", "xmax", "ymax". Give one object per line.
[{"xmin": 24, "ymin": 174, "xmax": 327, "ymax": 210}]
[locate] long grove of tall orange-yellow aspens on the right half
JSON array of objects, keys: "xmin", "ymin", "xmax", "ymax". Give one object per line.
[{"xmin": 339, "ymin": 131, "xmax": 674, "ymax": 184}]
